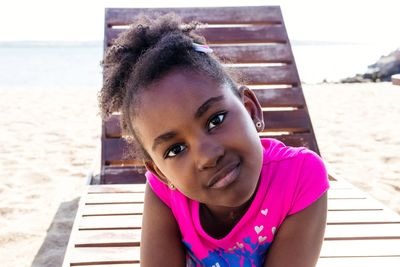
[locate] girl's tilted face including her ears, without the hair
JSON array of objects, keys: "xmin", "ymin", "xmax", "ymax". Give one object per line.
[{"xmin": 134, "ymin": 69, "xmax": 262, "ymax": 207}]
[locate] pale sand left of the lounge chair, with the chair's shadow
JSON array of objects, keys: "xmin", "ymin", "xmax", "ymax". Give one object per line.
[{"xmin": 0, "ymin": 88, "xmax": 100, "ymax": 267}]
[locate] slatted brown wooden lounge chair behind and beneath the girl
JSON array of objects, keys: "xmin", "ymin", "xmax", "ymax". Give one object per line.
[{"xmin": 63, "ymin": 6, "xmax": 400, "ymax": 267}]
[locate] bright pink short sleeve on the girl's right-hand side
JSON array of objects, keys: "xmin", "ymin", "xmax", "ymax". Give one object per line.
[{"xmin": 288, "ymin": 150, "xmax": 329, "ymax": 215}]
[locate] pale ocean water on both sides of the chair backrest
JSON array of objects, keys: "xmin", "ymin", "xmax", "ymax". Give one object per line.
[{"xmin": 0, "ymin": 41, "xmax": 397, "ymax": 89}]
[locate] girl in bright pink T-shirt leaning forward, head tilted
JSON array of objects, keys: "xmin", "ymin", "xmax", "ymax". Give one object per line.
[{"xmin": 99, "ymin": 14, "xmax": 329, "ymax": 267}]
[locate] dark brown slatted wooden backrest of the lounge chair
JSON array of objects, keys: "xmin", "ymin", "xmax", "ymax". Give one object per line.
[{"xmin": 100, "ymin": 6, "xmax": 319, "ymax": 183}]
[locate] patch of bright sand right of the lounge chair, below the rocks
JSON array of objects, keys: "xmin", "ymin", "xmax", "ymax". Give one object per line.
[{"xmin": 304, "ymin": 83, "xmax": 400, "ymax": 213}]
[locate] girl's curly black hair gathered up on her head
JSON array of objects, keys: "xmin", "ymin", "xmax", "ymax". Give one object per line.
[{"xmin": 98, "ymin": 13, "xmax": 238, "ymax": 159}]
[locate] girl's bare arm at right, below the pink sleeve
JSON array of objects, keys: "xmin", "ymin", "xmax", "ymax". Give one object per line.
[{"xmin": 264, "ymin": 193, "xmax": 327, "ymax": 267}]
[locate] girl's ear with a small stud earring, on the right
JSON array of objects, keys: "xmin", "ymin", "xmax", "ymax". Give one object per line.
[{"xmin": 239, "ymin": 86, "xmax": 264, "ymax": 131}]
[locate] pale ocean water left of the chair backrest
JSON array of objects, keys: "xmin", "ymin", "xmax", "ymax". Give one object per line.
[{"xmin": 0, "ymin": 42, "xmax": 103, "ymax": 89}]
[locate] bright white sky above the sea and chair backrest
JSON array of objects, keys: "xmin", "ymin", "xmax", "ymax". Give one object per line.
[{"xmin": 0, "ymin": 0, "xmax": 400, "ymax": 46}]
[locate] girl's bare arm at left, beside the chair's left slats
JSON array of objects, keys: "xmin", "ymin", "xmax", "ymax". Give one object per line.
[{"xmin": 140, "ymin": 184, "xmax": 186, "ymax": 267}]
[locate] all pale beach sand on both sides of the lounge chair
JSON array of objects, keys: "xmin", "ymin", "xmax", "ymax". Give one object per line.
[{"xmin": 0, "ymin": 83, "xmax": 400, "ymax": 267}]
